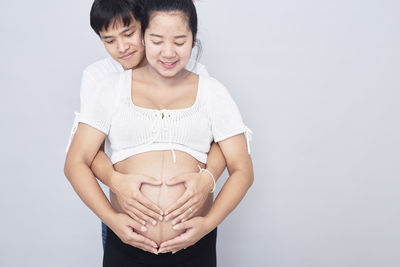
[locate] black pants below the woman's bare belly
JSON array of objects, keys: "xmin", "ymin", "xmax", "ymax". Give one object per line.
[{"xmin": 103, "ymin": 227, "xmax": 217, "ymax": 267}]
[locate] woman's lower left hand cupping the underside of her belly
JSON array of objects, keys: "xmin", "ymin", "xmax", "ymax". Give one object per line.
[{"xmin": 109, "ymin": 213, "xmax": 158, "ymax": 254}]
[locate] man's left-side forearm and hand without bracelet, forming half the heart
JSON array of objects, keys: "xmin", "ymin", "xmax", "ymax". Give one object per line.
[{"xmin": 91, "ymin": 143, "xmax": 163, "ymax": 225}]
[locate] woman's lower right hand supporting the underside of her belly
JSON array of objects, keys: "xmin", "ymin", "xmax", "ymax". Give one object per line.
[{"xmin": 158, "ymin": 217, "xmax": 212, "ymax": 253}]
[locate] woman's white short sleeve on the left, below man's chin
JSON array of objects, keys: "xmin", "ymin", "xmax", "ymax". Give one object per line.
[{"xmin": 79, "ymin": 73, "xmax": 118, "ymax": 134}]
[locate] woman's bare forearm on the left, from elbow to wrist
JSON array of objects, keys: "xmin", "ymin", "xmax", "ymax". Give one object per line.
[{"xmin": 65, "ymin": 160, "xmax": 116, "ymax": 227}]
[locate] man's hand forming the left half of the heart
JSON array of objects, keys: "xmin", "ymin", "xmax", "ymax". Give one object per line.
[{"xmin": 111, "ymin": 172, "xmax": 163, "ymax": 225}]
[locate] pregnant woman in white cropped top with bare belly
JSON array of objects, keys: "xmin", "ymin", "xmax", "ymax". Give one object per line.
[{"xmin": 65, "ymin": 0, "xmax": 253, "ymax": 266}]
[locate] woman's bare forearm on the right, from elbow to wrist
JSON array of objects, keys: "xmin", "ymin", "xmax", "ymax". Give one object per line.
[{"xmin": 205, "ymin": 170, "xmax": 253, "ymax": 231}]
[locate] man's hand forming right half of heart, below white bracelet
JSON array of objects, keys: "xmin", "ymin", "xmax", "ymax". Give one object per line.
[{"xmin": 165, "ymin": 172, "xmax": 213, "ymax": 224}]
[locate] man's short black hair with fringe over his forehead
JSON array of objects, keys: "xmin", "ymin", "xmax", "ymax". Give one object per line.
[{"xmin": 90, "ymin": 0, "xmax": 143, "ymax": 36}]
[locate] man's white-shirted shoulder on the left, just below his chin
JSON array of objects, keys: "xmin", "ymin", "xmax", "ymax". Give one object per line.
[{"xmin": 83, "ymin": 57, "xmax": 123, "ymax": 79}]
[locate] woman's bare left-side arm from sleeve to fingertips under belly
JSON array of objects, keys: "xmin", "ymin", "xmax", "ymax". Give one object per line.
[{"xmin": 64, "ymin": 123, "xmax": 157, "ymax": 253}]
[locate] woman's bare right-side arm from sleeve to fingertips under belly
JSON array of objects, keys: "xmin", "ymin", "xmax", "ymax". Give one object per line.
[{"xmin": 159, "ymin": 134, "xmax": 254, "ymax": 253}]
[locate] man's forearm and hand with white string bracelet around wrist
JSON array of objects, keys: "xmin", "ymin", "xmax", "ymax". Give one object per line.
[{"xmin": 165, "ymin": 143, "xmax": 226, "ymax": 224}]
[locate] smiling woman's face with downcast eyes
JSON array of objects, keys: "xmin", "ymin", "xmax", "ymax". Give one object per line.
[{"xmin": 144, "ymin": 11, "xmax": 193, "ymax": 78}]
